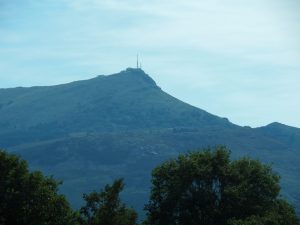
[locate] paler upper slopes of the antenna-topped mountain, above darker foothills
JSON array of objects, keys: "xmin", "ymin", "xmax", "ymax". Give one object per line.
[{"xmin": 0, "ymin": 68, "xmax": 232, "ymax": 147}]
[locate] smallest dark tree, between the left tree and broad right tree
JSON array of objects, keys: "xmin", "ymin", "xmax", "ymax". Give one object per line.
[{"xmin": 80, "ymin": 179, "xmax": 137, "ymax": 225}]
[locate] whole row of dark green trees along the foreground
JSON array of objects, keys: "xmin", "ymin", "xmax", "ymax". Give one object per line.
[{"xmin": 0, "ymin": 147, "xmax": 299, "ymax": 225}]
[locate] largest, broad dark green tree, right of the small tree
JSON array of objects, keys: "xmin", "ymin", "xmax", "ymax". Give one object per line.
[{"xmin": 145, "ymin": 146, "xmax": 299, "ymax": 225}]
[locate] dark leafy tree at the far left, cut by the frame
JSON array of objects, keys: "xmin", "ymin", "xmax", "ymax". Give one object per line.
[{"xmin": 0, "ymin": 151, "xmax": 76, "ymax": 225}]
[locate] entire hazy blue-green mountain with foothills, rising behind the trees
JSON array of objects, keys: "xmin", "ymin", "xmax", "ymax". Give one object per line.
[{"xmin": 0, "ymin": 68, "xmax": 300, "ymax": 216}]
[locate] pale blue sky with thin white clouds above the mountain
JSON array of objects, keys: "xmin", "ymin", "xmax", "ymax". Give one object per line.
[{"xmin": 0, "ymin": 0, "xmax": 300, "ymax": 128}]
